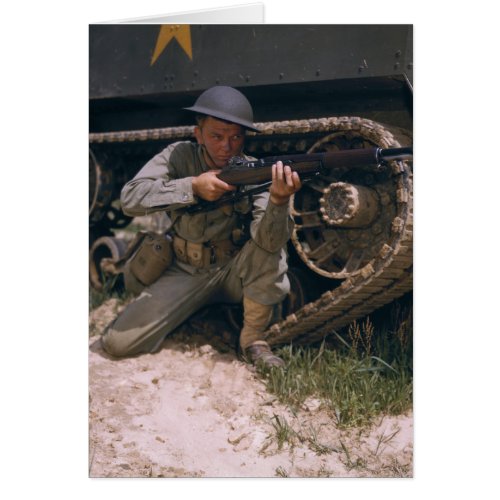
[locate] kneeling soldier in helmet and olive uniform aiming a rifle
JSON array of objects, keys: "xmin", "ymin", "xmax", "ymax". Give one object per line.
[{"xmin": 102, "ymin": 86, "xmax": 301, "ymax": 366}]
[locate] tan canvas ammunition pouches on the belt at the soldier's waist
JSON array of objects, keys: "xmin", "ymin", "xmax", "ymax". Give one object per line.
[{"xmin": 174, "ymin": 236, "xmax": 240, "ymax": 269}]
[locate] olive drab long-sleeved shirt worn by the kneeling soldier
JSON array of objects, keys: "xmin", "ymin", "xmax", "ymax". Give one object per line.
[{"xmin": 121, "ymin": 141, "xmax": 293, "ymax": 252}]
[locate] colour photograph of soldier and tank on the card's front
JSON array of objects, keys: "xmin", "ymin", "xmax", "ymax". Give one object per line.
[{"xmin": 89, "ymin": 23, "xmax": 414, "ymax": 478}]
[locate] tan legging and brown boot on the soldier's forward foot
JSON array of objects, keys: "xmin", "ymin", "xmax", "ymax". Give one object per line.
[{"xmin": 240, "ymin": 297, "xmax": 285, "ymax": 366}]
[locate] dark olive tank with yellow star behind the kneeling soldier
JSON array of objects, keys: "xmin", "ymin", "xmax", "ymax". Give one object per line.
[{"xmin": 89, "ymin": 24, "xmax": 413, "ymax": 344}]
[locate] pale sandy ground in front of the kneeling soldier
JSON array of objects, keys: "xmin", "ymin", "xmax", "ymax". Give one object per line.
[{"xmin": 89, "ymin": 299, "xmax": 413, "ymax": 477}]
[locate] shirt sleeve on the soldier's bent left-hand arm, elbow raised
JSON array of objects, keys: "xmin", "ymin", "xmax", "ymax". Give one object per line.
[{"xmin": 120, "ymin": 142, "xmax": 197, "ymax": 217}]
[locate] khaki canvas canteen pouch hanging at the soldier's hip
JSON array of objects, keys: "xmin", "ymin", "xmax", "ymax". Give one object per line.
[{"xmin": 128, "ymin": 233, "xmax": 173, "ymax": 286}]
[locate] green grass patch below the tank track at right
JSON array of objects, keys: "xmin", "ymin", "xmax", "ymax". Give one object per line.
[{"xmin": 258, "ymin": 296, "xmax": 413, "ymax": 428}]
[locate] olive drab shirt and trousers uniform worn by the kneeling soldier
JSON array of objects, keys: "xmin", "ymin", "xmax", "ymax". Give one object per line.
[{"xmin": 103, "ymin": 142, "xmax": 293, "ymax": 356}]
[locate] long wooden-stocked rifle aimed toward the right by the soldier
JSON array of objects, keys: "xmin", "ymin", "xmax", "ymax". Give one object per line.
[{"xmin": 186, "ymin": 146, "xmax": 413, "ymax": 213}]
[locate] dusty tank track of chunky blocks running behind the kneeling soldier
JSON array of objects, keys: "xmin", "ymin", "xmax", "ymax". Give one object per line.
[{"xmin": 89, "ymin": 117, "xmax": 413, "ymax": 345}]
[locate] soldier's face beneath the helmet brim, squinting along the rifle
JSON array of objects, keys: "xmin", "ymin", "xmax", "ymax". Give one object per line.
[{"xmin": 194, "ymin": 116, "xmax": 245, "ymax": 168}]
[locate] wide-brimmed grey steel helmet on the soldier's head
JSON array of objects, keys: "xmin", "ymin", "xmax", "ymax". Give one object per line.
[{"xmin": 183, "ymin": 85, "xmax": 260, "ymax": 132}]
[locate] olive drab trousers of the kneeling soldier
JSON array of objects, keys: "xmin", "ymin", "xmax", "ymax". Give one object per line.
[{"xmin": 102, "ymin": 240, "xmax": 290, "ymax": 357}]
